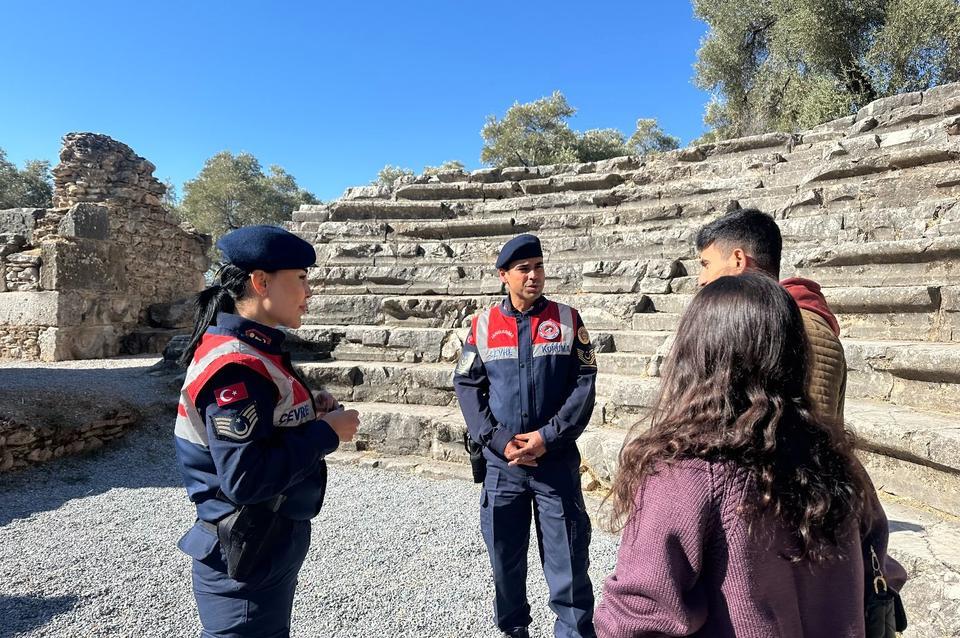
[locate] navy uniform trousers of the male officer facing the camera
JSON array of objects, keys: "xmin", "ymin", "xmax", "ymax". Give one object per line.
[{"xmin": 480, "ymin": 448, "xmax": 596, "ymax": 638}]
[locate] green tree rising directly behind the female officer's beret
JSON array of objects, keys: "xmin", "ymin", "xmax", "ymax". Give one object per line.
[{"xmin": 180, "ymin": 151, "xmax": 318, "ymax": 238}]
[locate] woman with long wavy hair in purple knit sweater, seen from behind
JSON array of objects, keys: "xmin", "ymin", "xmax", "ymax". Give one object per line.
[{"xmin": 595, "ymin": 274, "xmax": 905, "ymax": 638}]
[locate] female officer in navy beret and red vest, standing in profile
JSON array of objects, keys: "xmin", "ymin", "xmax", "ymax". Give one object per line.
[{"xmin": 175, "ymin": 226, "xmax": 358, "ymax": 638}]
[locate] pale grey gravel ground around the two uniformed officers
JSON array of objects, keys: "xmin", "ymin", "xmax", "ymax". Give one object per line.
[{"xmin": 0, "ymin": 392, "xmax": 616, "ymax": 638}]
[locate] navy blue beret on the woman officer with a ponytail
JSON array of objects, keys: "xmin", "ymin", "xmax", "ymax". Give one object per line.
[{"xmin": 217, "ymin": 226, "xmax": 317, "ymax": 272}]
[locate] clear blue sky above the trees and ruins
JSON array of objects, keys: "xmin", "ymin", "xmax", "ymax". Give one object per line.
[{"xmin": 0, "ymin": 0, "xmax": 708, "ymax": 200}]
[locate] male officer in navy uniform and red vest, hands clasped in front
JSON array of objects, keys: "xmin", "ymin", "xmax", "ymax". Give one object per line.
[{"xmin": 453, "ymin": 235, "xmax": 597, "ymax": 638}]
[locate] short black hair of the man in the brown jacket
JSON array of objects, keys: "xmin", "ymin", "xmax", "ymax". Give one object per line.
[{"xmin": 697, "ymin": 208, "xmax": 783, "ymax": 278}]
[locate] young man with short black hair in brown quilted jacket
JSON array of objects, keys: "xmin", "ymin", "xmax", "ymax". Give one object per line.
[{"xmin": 697, "ymin": 209, "xmax": 847, "ymax": 419}]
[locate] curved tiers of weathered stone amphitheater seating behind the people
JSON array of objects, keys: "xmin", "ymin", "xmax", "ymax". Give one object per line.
[{"xmin": 292, "ymin": 84, "xmax": 960, "ymax": 636}]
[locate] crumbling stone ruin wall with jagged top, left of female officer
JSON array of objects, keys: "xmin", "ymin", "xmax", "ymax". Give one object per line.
[{"xmin": 0, "ymin": 133, "xmax": 210, "ymax": 361}]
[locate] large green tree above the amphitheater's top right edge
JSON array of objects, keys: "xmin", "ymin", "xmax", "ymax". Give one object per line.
[{"xmin": 693, "ymin": 0, "xmax": 960, "ymax": 141}]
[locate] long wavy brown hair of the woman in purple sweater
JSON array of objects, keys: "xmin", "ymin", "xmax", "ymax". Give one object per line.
[{"xmin": 611, "ymin": 274, "xmax": 869, "ymax": 562}]
